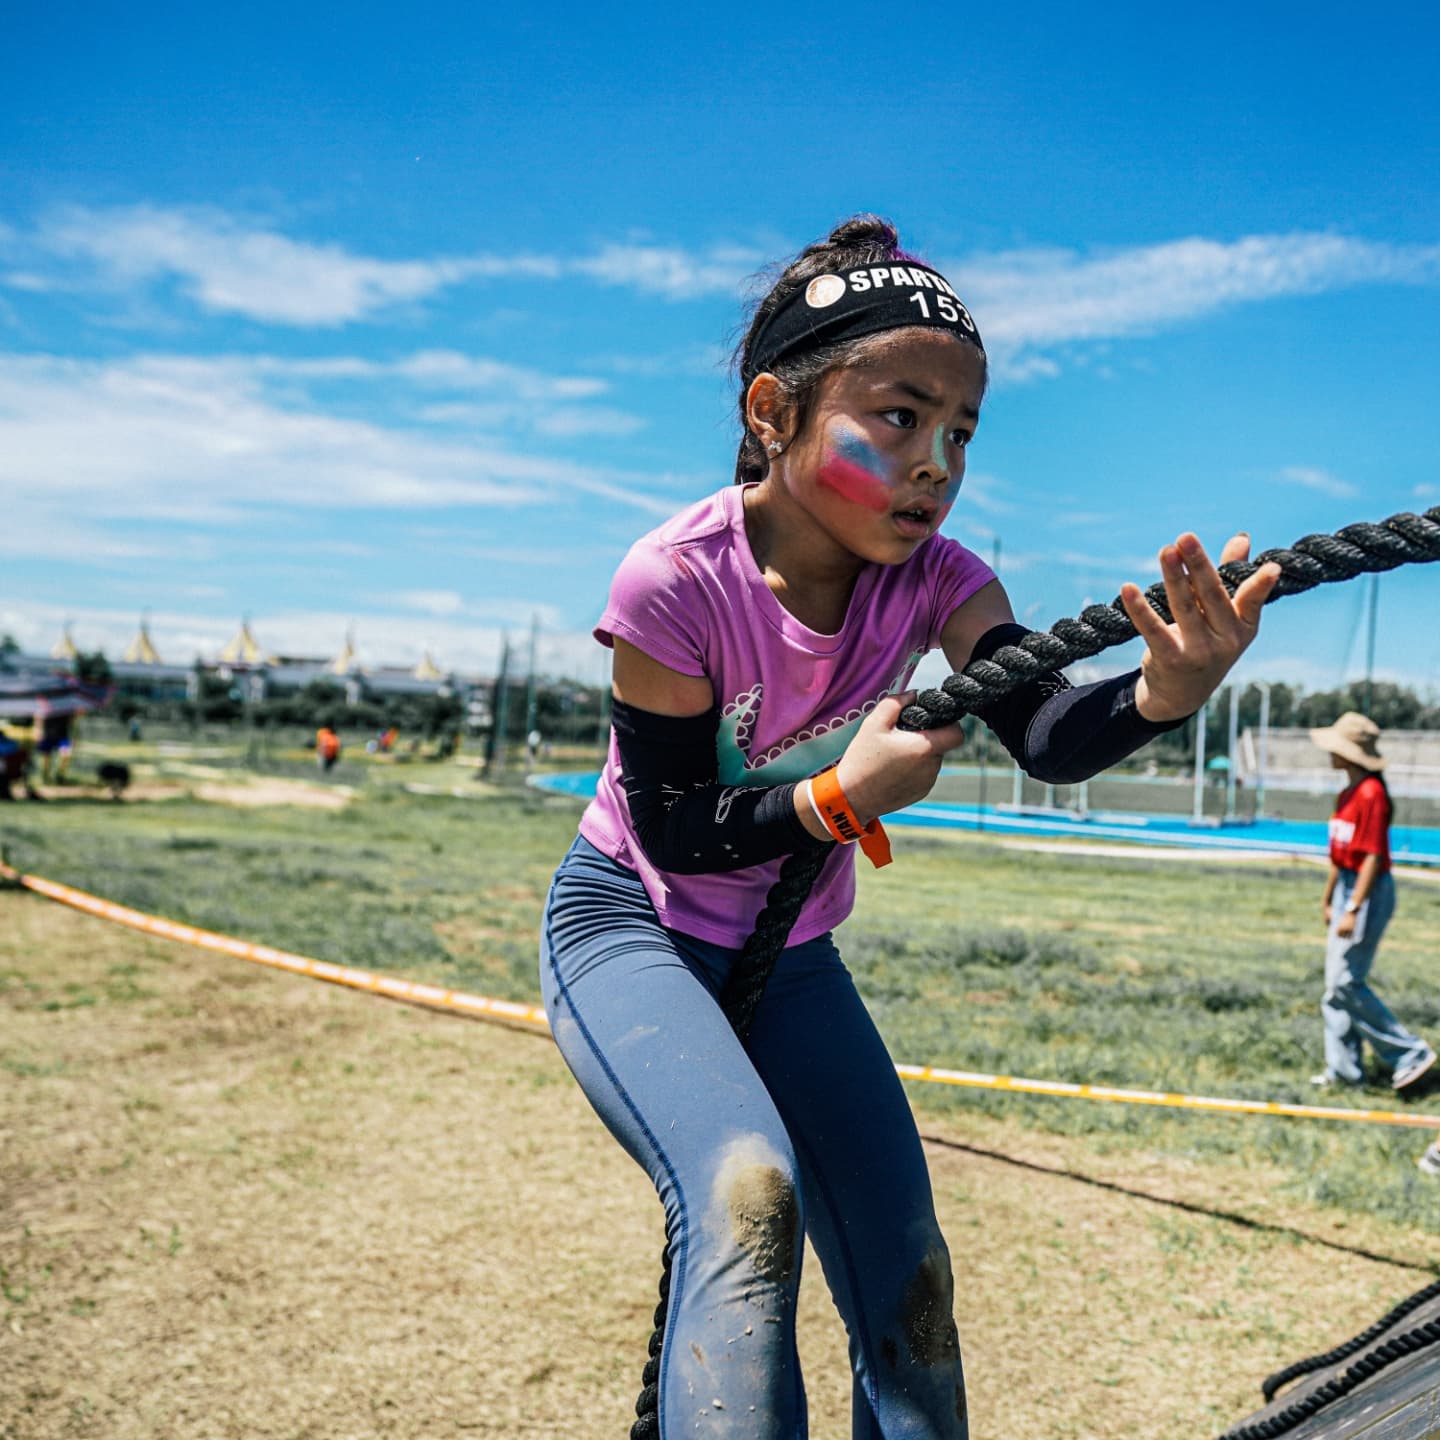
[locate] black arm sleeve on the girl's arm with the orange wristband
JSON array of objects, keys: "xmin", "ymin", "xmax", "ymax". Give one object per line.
[{"xmin": 611, "ymin": 700, "xmax": 825, "ymax": 876}]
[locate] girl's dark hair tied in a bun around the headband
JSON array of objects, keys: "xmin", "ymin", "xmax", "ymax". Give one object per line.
[{"xmin": 730, "ymin": 215, "xmax": 984, "ymax": 485}]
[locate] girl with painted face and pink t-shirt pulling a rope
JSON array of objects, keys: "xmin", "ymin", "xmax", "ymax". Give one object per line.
[{"xmin": 541, "ymin": 216, "xmax": 1279, "ymax": 1440}]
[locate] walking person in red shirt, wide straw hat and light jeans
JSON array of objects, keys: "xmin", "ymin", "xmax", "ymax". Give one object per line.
[{"xmin": 1310, "ymin": 710, "xmax": 1436, "ymax": 1093}]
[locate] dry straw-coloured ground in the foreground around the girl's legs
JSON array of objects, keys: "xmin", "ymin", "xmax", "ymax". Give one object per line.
[{"xmin": 0, "ymin": 890, "xmax": 1433, "ymax": 1440}]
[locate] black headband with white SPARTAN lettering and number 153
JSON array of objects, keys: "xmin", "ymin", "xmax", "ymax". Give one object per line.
[{"xmin": 740, "ymin": 261, "xmax": 985, "ymax": 386}]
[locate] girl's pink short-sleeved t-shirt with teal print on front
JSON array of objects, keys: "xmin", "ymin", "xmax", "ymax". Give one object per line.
[{"xmin": 580, "ymin": 485, "xmax": 995, "ymax": 946}]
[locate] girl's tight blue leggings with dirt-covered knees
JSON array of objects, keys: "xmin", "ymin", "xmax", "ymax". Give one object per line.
[{"xmin": 540, "ymin": 838, "xmax": 969, "ymax": 1440}]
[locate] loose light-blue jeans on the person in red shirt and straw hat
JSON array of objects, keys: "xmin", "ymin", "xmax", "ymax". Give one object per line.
[{"xmin": 1320, "ymin": 870, "xmax": 1426, "ymax": 1084}]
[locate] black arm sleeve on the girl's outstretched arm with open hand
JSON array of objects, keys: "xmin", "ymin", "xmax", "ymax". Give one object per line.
[{"xmin": 971, "ymin": 622, "xmax": 1189, "ymax": 785}]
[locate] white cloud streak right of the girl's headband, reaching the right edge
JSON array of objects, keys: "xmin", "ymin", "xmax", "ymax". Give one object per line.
[{"xmin": 945, "ymin": 232, "xmax": 1440, "ymax": 380}]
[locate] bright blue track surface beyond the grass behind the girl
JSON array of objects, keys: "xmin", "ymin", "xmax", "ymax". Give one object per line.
[{"xmin": 530, "ymin": 770, "xmax": 1440, "ymax": 865}]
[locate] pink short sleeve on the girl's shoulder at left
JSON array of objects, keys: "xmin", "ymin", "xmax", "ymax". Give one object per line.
[{"xmin": 595, "ymin": 536, "xmax": 708, "ymax": 677}]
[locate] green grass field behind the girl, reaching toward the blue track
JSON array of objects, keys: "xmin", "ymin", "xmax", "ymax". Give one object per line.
[{"xmin": 0, "ymin": 744, "xmax": 1440, "ymax": 1227}]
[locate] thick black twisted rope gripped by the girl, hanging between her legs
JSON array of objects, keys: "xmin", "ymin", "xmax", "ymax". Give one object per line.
[{"xmin": 631, "ymin": 505, "xmax": 1440, "ymax": 1440}]
